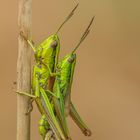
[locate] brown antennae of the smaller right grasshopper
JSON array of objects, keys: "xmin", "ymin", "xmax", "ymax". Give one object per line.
[{"xmin": 72, "ymin": 16, "xmax": 95, "ymax": 54}]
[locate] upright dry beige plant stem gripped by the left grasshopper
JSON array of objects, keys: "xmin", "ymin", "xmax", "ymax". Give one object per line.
[{"xmin": 17, "ymin": 0, "xmax": 32, "ymax": 140}]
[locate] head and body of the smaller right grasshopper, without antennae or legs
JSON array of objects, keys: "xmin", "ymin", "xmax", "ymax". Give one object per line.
[{"xmin": 53, "ymin": 54, "xmax": 76, "ymax": 115}]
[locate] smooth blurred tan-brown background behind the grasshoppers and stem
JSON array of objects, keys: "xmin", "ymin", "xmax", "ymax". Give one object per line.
[{"xmin": 0, "ymin": 0, "xmax": 140, "ymax": 140}]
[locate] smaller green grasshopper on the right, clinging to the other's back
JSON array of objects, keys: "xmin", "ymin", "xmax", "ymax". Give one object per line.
[{"xmin": 48, "ymin": 17, "xmax": 94, "ymax": 136}]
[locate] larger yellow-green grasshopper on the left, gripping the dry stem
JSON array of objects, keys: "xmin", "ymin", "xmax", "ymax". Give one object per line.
[{"xmin": 17, "ymin": 4, "xmax": 78, "ymax": 140}]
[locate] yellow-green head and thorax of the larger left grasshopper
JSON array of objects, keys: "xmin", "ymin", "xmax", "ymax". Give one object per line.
[{"xmin": 32, "ymin": 35, "xmax": 60, "ymax": 95}]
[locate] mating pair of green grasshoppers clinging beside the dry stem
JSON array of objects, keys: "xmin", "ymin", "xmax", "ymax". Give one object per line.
[{"xmin": 17, "ymin": 4, "xmax": 94, "ymax": 140}]
